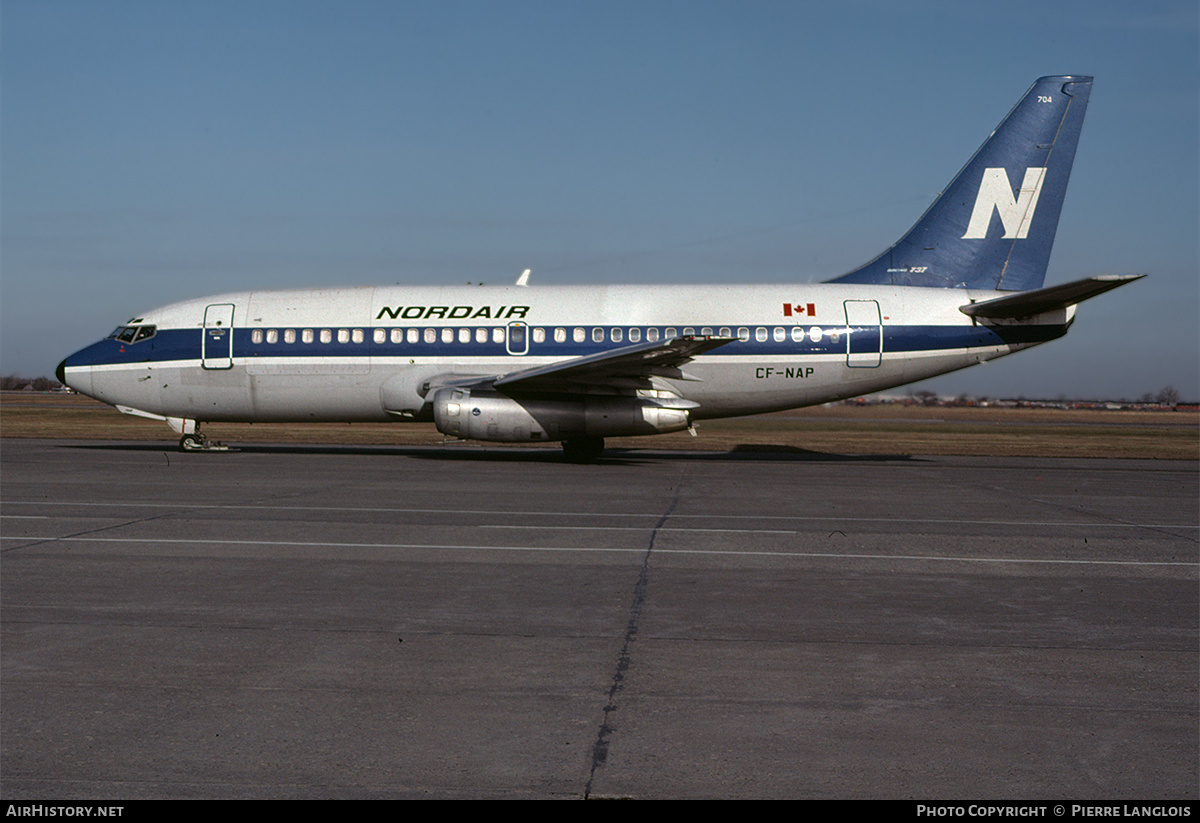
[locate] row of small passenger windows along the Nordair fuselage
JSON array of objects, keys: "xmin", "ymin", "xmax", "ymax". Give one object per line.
[{"xmin": 250, "ymin": 324, "xmax": 839, "ymax": 344}]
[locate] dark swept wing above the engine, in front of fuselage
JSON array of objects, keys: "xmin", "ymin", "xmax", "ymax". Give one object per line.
[{"xmin": 492, "ymin": 336, "xmax": 737, "ymax": 394}]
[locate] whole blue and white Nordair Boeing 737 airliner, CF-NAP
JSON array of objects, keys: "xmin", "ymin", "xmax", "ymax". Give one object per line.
[{"xmin": 58, "ymin": 77, "xmax": 1140, "ymax": 462}]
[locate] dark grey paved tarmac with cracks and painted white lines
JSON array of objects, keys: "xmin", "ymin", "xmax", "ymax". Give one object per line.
[{"xmin": 0, "ymin": 439, "xmax": 1200, "ymax": 800}]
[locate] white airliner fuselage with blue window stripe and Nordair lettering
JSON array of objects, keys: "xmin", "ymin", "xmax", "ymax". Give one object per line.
[{"xmin": 64, "ymin": 284, "xmax": 1073, "ymax": 429}]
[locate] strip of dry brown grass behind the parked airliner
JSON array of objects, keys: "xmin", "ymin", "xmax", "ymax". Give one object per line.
[{"xmin": 0, "ymin": 392, "xmax": 1200, "ymax": 459}]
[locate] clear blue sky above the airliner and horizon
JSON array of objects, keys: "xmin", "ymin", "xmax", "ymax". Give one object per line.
[{"xmin": 0, "ymin": 0, "xmax": 1200, "ymax": 398}]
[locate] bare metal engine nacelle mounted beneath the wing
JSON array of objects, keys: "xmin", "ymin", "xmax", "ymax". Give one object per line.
[{"xmin": 433, "ymin": 388, "xmax": 690, "ymax": 443}]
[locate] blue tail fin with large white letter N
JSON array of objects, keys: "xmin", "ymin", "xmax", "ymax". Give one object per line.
[{"xmin": 829, "ymin": 77, "xmax": 1092, "ymax": 292}]
